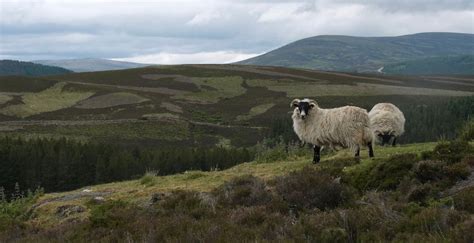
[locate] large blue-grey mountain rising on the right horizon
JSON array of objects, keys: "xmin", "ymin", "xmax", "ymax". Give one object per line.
[{"xmin": 238, "ymin": 33, "xmax": 474, "ymax": 72}]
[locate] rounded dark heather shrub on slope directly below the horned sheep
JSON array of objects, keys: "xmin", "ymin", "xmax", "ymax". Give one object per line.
[{"xmin": 275, "ymin": 167, "xmax": 353, "ymax": 210}]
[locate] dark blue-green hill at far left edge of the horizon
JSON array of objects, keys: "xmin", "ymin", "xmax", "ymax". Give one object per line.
[{"xmin": 0, "ymin": 60, "xmax": 72, "ymax": 77}]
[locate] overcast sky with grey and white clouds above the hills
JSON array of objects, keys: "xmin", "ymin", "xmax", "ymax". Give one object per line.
[{"xmin": 0, "ymin": 0, "xmax": 474, "ymax": 64}]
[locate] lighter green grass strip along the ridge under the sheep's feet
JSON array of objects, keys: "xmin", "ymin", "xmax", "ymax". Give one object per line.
[{"xmin": 27, "ymin": 143, "xmax": 436, "ymax": 228}]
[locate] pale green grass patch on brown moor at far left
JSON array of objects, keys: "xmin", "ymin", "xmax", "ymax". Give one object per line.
[{"xmin": 0, "ymin": 83, "xmax": 94, "ymax": 118}]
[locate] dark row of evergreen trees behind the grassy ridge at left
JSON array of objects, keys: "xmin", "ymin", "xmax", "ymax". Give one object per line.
[{"xmin": 0, "ymin": 137, "xmax": 254, "ymax": 195}]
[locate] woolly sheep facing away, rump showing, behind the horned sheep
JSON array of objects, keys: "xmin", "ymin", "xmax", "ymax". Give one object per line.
[{"xmin": 369, "ymin": 103, "xmax": 405, "ymax": 146}]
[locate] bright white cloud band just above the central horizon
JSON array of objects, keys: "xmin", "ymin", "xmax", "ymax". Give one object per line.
[{"xmin": 112, "ymin": 51, "xmax": 261, "ymax": 64}]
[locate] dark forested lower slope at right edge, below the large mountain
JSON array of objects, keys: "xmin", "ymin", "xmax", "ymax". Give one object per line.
[{"xmin": 381, "ymin": 55, "xmax": 474, "ymax": 75}]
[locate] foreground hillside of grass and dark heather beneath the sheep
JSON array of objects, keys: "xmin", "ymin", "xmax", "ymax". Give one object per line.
[{"xmin": 0, "ymin": 142, "xmax": 474, "ymax": 242}]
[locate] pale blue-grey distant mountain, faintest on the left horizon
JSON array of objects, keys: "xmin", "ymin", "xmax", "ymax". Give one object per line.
[{"xmin": 33, "ymin": 58, "xmax": 150, "ymax": 72}]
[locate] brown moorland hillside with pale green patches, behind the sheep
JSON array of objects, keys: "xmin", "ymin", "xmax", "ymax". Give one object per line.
[{"xmin": 0, "ymin": 65, "xmax": 474, "ymax": 147}]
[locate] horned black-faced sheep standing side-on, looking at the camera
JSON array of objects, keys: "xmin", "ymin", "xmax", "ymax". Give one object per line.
[{"xmin": 290, "ymin": 98, "xmax": 374, "ymax": 164}]
